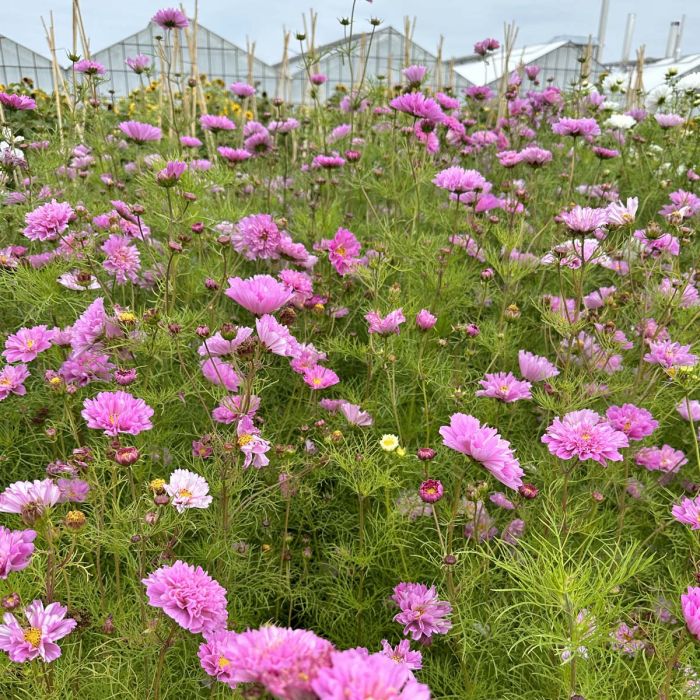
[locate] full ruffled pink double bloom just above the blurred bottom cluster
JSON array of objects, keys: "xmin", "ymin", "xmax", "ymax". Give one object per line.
[{"xmin": 141, "ymin": 560, "xmax": 228, "ymax": 634}]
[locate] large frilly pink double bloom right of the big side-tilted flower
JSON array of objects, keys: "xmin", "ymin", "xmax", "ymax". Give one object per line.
[{"xmin": 542, "ymin": 409, "xmax": 629, "ymax": 467}]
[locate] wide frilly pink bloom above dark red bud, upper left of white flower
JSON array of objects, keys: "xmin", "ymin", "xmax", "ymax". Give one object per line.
[{"xmin": 81, "ymin": 391, "xmax": 153, "ymax": 437}]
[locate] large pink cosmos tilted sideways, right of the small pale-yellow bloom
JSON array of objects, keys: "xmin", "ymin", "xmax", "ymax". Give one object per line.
[{"xmin": 439, "ymin": 413, "xmax": 524, "ymax": 489}]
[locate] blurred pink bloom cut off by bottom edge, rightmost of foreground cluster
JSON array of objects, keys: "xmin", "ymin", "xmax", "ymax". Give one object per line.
[{"xmin": 311, "ymin": 647, "xmax": 430, "ymax": 700}]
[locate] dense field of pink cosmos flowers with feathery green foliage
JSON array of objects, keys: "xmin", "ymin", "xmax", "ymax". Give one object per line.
[{"xmin": 0, "ymin": 5, "xmax": 700, "ymax": 700}]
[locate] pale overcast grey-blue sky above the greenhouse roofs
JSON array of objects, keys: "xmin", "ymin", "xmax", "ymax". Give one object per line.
[{"xmin": 5, "ymin": 0, "xmax": 700, "ymax": 63}]
